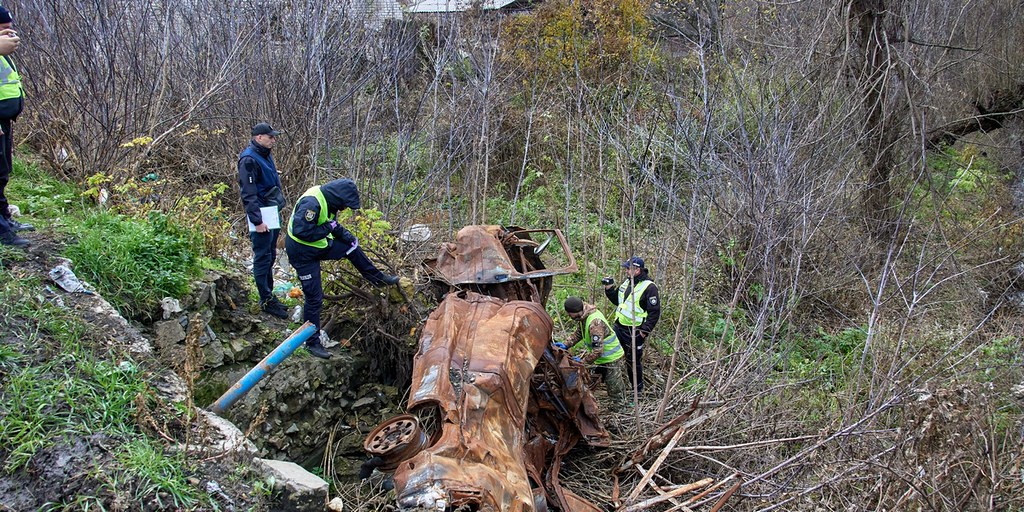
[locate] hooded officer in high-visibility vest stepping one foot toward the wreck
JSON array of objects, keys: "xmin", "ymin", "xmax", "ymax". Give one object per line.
[{"xmin": 285, "ymin": 179, "xmax": 398, "ymax": 359}]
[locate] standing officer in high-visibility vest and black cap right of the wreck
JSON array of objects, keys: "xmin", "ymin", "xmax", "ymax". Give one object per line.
[{"xmin": 601, "ymin": 256, "xmax": 662, "ymax": 393}]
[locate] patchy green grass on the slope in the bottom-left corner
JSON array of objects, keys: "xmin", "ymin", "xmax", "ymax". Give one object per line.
[{"xmin": 0, "ymin": 270, "xmax": 209, "ymax": 510}]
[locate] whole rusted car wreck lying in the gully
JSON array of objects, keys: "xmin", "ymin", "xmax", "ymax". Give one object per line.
[{"xmin": 365, "ymin": 225, "xmax": 609, "ymax": 511}]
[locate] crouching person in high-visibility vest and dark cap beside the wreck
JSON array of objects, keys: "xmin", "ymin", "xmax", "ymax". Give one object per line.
[{"xmin": 562, "ymin": 297, "xmax": 625, "ymax": 408}]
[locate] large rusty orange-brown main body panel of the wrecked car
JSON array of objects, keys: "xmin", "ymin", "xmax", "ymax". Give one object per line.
[{"xmin": 394, "ymin": 292, "xmax": 553, "ymax": 511}]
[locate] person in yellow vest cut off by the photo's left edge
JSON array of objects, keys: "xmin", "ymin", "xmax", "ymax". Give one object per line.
[{"xmin": 0, "ymin": 7, "xmax": 30, "ymax": 247}]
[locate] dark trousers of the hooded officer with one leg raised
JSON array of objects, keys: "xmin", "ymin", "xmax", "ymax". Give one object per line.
[{"xmin": 285, "ymin": 237, "xmax": 385, "ymax": 329}]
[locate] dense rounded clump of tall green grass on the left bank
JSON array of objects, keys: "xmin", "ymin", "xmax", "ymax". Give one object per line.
[{"xmin": 67, "ymin": 207, "xmax": 201, "ymax": 316}]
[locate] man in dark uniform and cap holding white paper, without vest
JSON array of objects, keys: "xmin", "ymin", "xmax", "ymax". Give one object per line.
[{"xmin": 239, "ymin": 123, "xmax": 288, "ymax": 318}]
